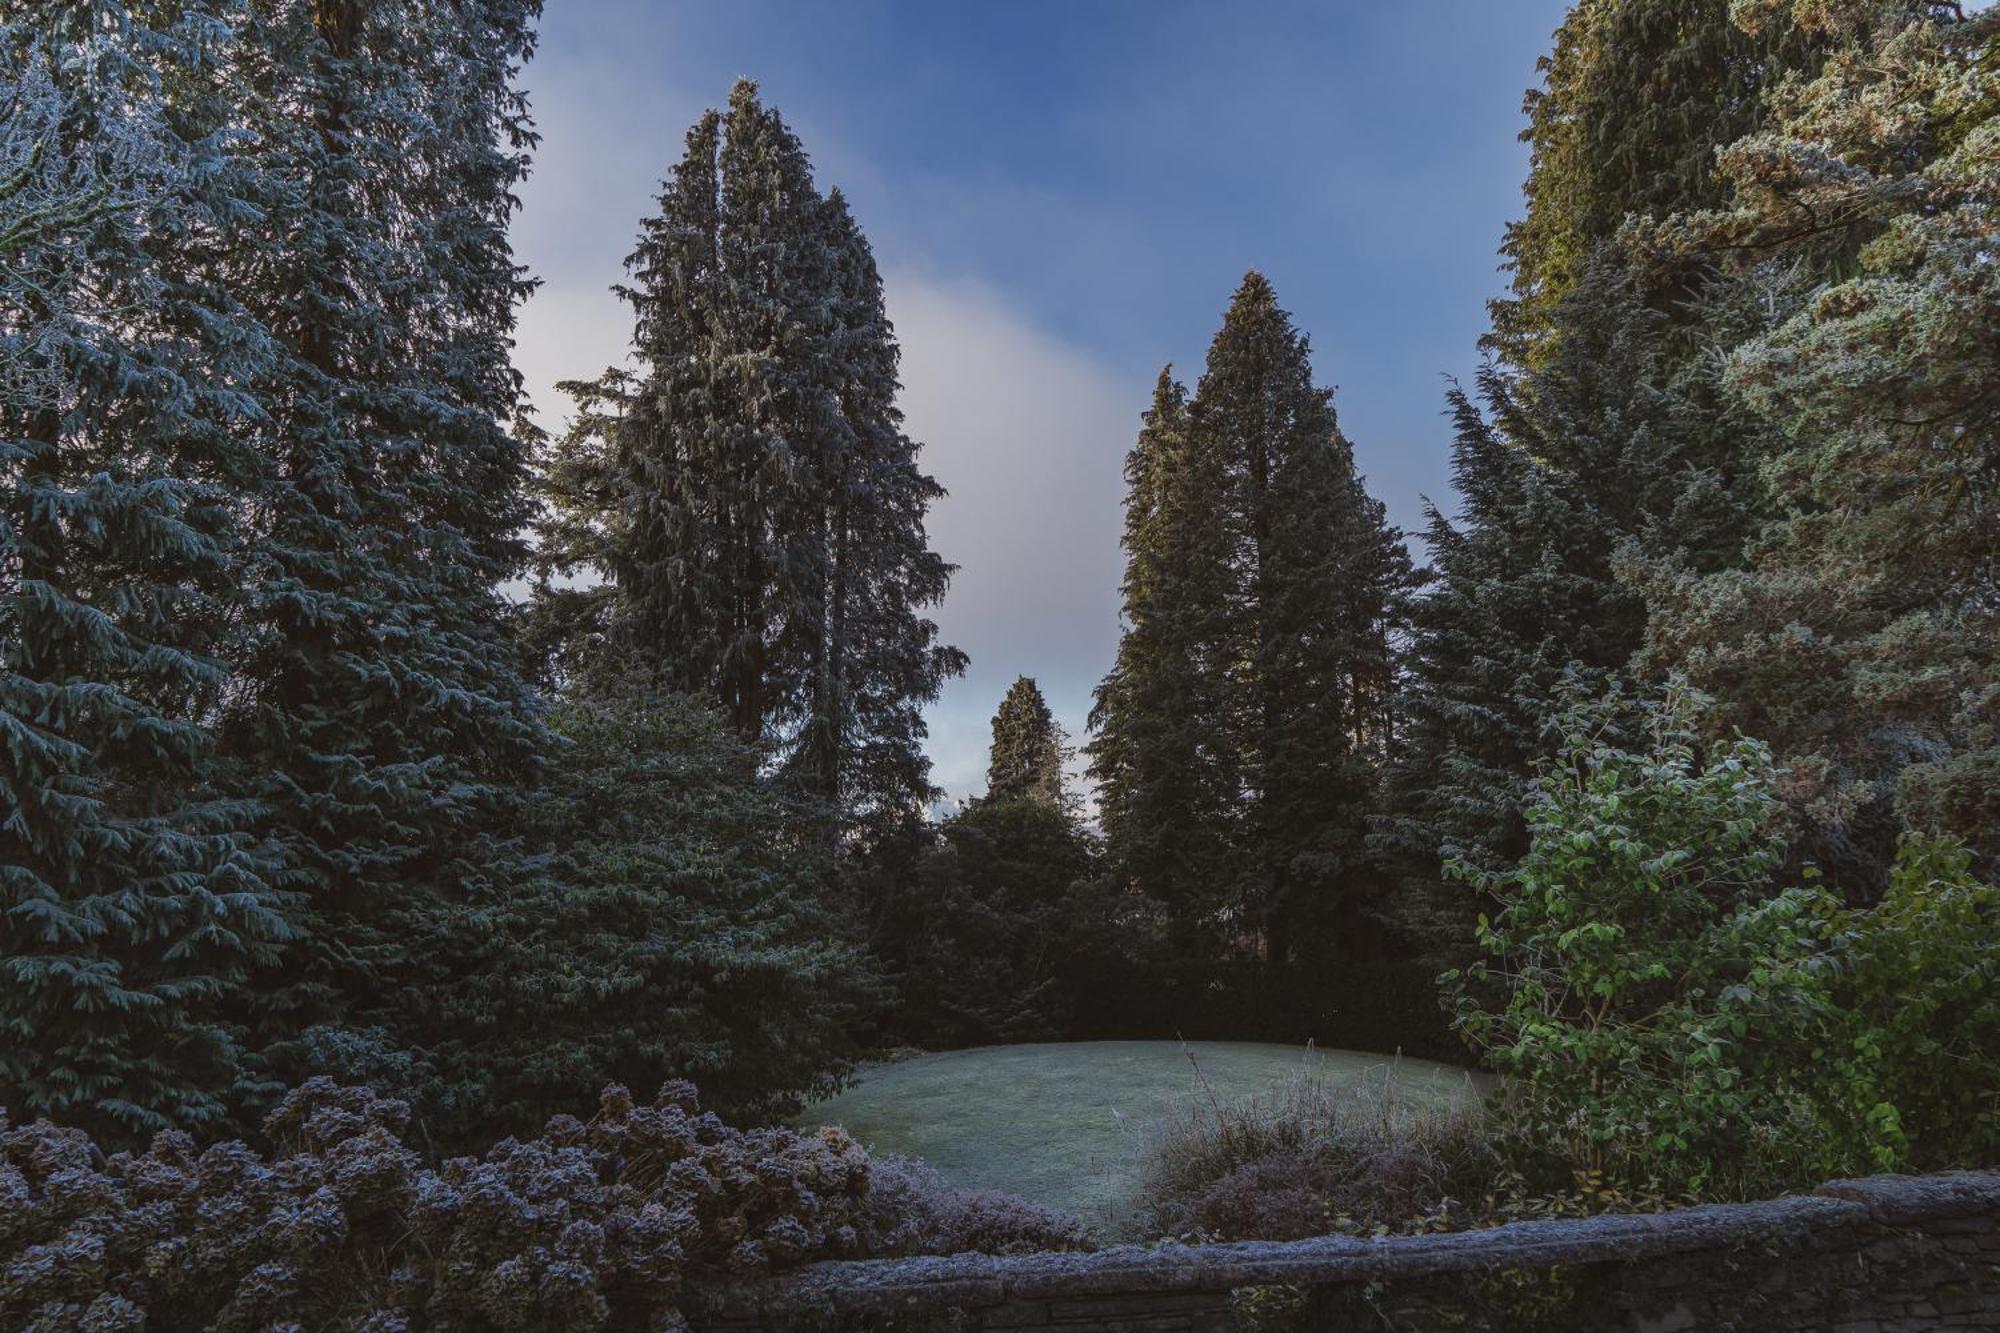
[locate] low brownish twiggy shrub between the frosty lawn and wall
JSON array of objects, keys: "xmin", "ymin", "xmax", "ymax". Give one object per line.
[{"xmin": 1146, "ymin": 1071, "xmax": 1498, "ymax": 1241}]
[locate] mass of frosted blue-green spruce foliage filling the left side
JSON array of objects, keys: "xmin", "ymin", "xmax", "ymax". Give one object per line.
[{"xmin": 0, "ymin": 0, "xmax": 540, "ymax": 1133}]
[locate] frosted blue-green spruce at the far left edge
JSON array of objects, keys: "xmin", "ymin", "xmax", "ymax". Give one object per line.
[{"xmin": 0, "ymin": 4, "xmax": 292, "ymax": 1141}]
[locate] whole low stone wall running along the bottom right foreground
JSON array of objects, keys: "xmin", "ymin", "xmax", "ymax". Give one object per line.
[{"xmin": 688, "ymin": 1173, "xmax": 2000, "ymax": 1333}]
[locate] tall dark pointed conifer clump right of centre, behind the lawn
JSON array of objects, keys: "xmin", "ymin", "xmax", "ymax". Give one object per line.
[{"xmin": 1092, "ymin": 272, "xmax": 1412, "ymax": 961}]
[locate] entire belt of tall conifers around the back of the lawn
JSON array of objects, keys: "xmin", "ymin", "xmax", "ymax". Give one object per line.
[{"xmin": 0, "ymin": 0, "xmax": 2000, "ymax": 1147}]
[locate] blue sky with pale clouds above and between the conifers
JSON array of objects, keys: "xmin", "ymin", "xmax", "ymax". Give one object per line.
[{"xmin": 514, "ymin": 0, "xmax": 1564, "ymax": 797}]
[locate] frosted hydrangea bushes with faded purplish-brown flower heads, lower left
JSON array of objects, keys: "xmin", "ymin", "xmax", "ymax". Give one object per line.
[{"xmin": 0, "ymin": 1079, "xmax": 1082, "ymax": 1333}]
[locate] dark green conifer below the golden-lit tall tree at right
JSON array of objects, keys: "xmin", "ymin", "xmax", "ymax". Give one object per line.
[{"xmin": 1378, "ymin": 254, "xmax": 1768, "ymax": 953}]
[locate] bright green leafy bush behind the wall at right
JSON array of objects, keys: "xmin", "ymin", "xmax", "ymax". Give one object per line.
[{"xmin": 1448, "ymin": 687, "xmax": 2000, "ymax": 1197}]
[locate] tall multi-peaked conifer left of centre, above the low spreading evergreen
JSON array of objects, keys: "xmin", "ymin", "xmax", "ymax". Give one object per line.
[{"xmin": 542, "ymin": 82, "xmax": 964, "ymax": 819}]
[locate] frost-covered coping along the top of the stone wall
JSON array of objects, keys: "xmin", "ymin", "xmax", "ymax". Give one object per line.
[{"xmin": 686, "ymin": 1171, "xmax": 2000, "ymax": 1323}]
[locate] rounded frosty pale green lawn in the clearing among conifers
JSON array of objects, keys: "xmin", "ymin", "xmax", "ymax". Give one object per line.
[{"xmin": 798, "ymin": 1041, "xmax": 1468, "ymax": 1235}]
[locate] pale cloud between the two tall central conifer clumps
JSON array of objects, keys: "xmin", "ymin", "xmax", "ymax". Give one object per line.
[{"xmin": 884, "ymin": 270, "xmax": 1148, "ymax": 797}]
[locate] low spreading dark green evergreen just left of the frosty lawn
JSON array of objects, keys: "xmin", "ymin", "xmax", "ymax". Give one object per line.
[{"xmin": 386, "ymin": 675, "xmax": 882, "ymax": 1145}]
